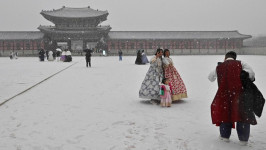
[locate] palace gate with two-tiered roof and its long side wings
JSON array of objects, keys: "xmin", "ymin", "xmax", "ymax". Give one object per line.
[{"xmin": 0, "ymin": 6, "xmax": 251, "ymax": 54}]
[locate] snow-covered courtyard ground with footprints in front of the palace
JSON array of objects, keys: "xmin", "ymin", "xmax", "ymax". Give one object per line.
[{"xmin": 0, "ymin": 55, "xmax": 266, "ymax": 150}]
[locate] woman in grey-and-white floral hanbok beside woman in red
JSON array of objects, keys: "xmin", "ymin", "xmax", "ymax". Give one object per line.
[{"xmin": 139, "ymin": 49, "xmax": 163, "ymax": 104}]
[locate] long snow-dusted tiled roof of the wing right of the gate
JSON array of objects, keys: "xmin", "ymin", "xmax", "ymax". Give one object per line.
[{"xmin": 109, "ymin": 31, "xmax": 251, "ymax": 39}]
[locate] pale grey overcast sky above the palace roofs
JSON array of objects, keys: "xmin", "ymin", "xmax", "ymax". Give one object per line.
[{"xmin": 0, "ymin": 0, "xmax": 266, "ymax": 35}]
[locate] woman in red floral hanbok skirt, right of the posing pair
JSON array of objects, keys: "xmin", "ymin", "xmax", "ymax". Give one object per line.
[{"xmin": 163, "ymin": 49, "xmax": 187, "ymax": 101}]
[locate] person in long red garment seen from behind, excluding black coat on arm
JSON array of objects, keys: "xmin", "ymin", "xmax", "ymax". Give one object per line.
[{"xmin": 208, "ymin": 51, "xmax": 255, "ymax": 144}]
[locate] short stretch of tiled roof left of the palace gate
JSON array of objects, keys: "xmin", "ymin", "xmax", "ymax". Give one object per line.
[{"xmin": 0, "ymin": 31, "xmax": 44, "ymax": 40}]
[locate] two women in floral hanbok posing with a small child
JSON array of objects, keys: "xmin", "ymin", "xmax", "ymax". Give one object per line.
[{"xmin": 139, "ymin": 49, "xmax": 187, "ymax": 107}]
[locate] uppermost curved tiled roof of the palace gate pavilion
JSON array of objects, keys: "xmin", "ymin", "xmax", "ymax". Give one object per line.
[{"xmin": 41, "ymin": 7, "xmax": 108, "ymax": 18}]
